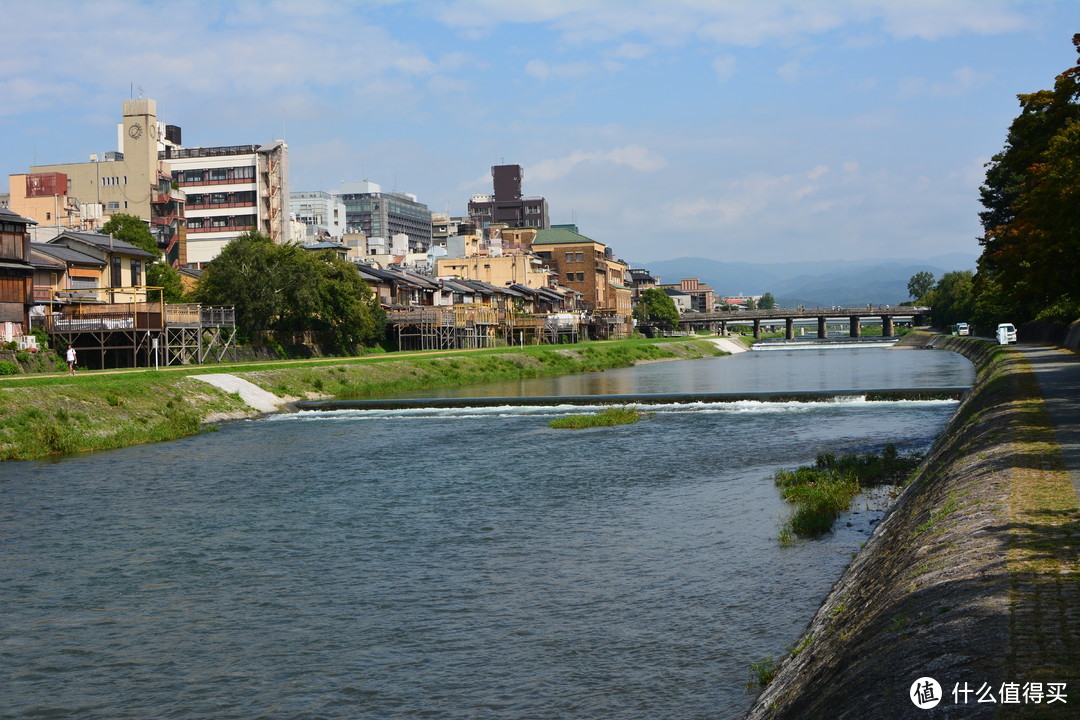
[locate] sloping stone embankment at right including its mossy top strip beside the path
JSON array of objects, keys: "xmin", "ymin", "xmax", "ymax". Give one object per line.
[{"xmin": 746, "ymin": 334, "xmax": 1080, "ymax": 720}]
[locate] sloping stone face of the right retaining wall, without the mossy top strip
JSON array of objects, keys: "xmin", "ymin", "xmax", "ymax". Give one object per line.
[{"xmin": 745, "ymin": 332, "xmax": 1025, "ymax": 720}]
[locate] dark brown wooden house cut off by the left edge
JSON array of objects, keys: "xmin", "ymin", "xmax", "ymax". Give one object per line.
[{"xmin": 0, "ymin": 208, "xmax": 35, "ymax": 342}]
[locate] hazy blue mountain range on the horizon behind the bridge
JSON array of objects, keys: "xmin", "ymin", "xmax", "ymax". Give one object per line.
[{"xmin": 630, "ymin": 253, "xmax": 977, "ymax": 308}]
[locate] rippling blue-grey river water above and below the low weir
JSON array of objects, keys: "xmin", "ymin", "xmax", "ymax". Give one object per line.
[{"xmin": 0, "ymin": 349, "xmax": 973, "ymax": 720}]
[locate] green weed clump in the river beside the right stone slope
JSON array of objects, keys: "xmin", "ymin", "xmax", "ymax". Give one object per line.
[{"xmin": 774, "ymin": 445, "xmax": 922, "ymax": 544}]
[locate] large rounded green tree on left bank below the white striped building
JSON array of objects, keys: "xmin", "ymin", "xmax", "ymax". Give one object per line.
[{"xmin": 195, "ymin": 230, "xmax": 386, "ymax": 347}]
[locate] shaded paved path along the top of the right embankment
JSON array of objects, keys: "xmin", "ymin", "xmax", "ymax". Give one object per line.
[{"xmin": 1016, "ymin": 344, "xmax": 1080, "ymax": 495}]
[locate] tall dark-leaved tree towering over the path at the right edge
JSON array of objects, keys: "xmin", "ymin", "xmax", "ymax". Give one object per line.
[{"xmin": 974, "ymin": 33, "xmax": 1080, "ymax": 324}]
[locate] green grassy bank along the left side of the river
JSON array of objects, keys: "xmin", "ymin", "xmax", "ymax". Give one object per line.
[{"xmin": 0, "ymin": 339, "xmax": 725, "ymax": 460}]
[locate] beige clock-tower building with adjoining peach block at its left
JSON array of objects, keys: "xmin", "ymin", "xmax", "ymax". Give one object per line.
[{"xmin": 20, "ymin": 98, "xmax": 184, "ymax": 262}]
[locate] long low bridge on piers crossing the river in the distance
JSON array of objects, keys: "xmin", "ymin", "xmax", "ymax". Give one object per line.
[{"xmin": 679, "ymin": 305, "xmax": 931, "ymax": 340}]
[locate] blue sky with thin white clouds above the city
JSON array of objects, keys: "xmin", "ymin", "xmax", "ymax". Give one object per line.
[{"xmin": 0, "ymin": 0, "xmax": 1080, "ymax": 263}]
